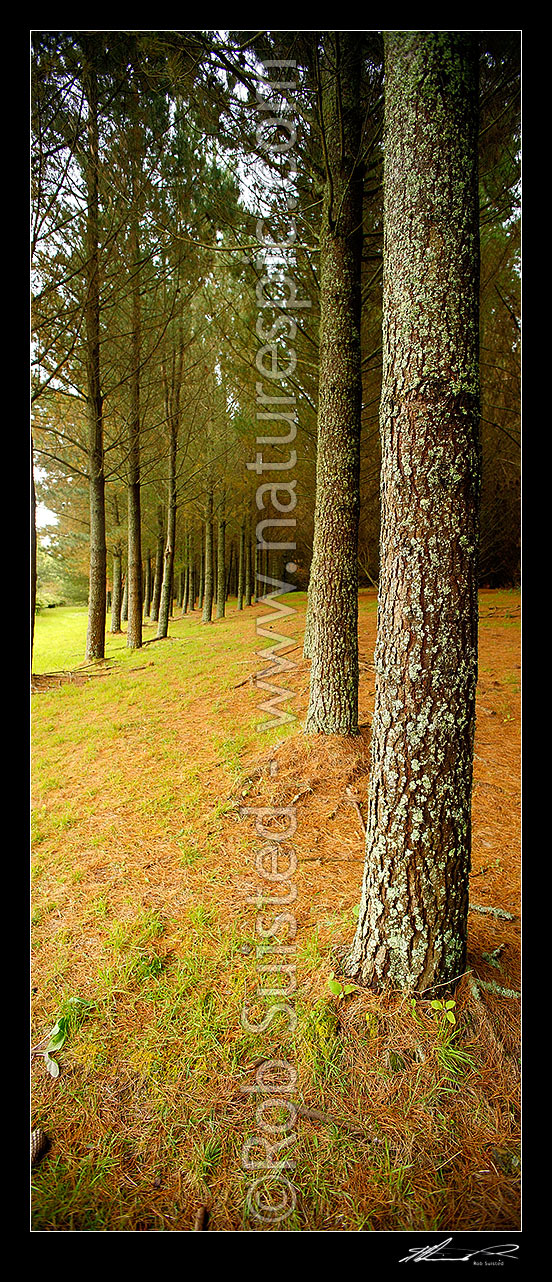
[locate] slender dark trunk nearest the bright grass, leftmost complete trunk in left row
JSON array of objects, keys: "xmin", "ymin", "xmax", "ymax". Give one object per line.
[{"xmin": 83, "ymin": 35, "xmax": 108, "ymax": 659}]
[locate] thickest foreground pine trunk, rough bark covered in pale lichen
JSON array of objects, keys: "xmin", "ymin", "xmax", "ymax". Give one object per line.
[{"xmin": 345, "ymin": 32, "xmax": 480, "ymax": 996}]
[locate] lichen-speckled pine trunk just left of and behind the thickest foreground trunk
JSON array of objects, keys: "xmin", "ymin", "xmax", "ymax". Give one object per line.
[{"xmin": 305, "ymin": 32, "xmax": 362, "ymax": 735}]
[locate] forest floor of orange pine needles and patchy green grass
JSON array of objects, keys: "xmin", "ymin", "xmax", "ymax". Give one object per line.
[{"xmin": 31, "ymin": 590, "xmax": 520, "ymax": 1232}]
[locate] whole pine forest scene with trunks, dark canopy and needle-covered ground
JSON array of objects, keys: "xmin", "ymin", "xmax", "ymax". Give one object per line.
[{"xmin": 28, "ymin": 29, "xmax": 523, "ymax": 1265}]
